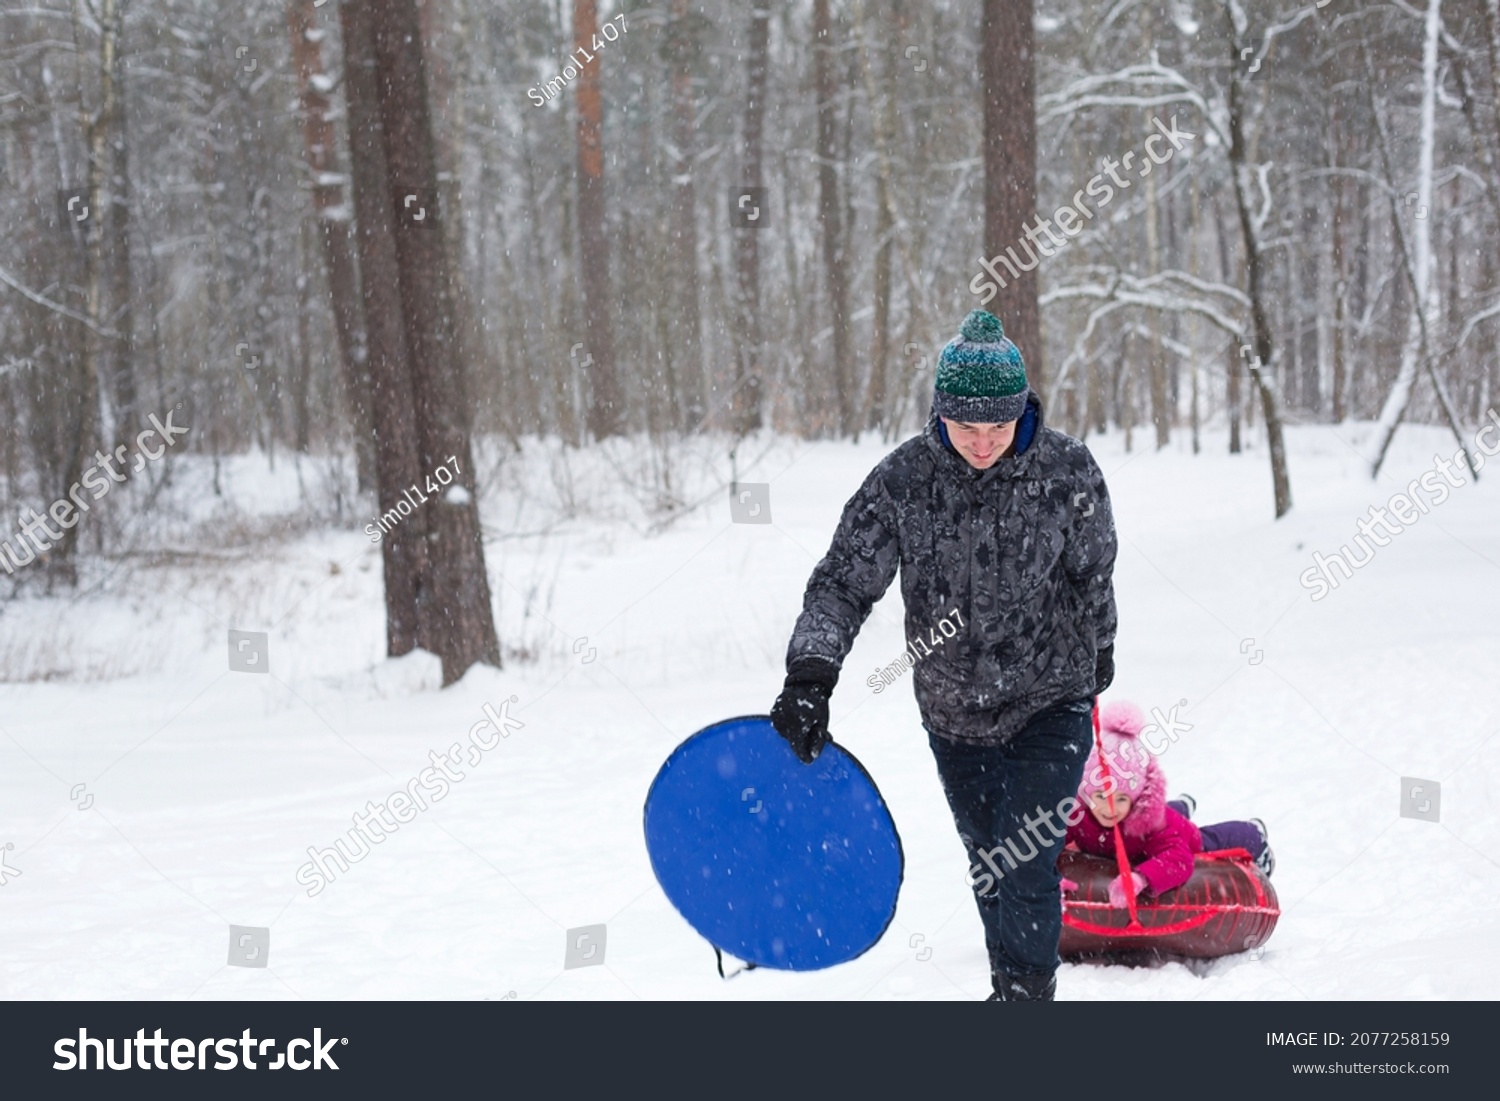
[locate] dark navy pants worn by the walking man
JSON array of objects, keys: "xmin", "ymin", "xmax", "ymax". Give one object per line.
[{"xmin": 927, "ymin": 699, "xmax": 1094, "ymax": 977}]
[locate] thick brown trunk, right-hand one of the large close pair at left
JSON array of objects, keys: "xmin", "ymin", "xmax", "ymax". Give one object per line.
[{"xmin": 372, "ymin": 0, "xmax": 500, "ymax": 686}]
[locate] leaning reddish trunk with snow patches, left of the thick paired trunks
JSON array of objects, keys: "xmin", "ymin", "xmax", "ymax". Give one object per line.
[{"xmin": 287, "ymin": 0, "xmax": 377, "ymax": 491}]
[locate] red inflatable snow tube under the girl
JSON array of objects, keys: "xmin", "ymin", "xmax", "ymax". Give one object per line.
[{"xmin": 1058, "ymin": 849, "xmax": 1281, "ymax": 959}]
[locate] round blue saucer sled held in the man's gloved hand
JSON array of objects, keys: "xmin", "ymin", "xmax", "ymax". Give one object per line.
[{"xmin": 645, "ymin": 716, "xmax": 905, "ymax": 971}]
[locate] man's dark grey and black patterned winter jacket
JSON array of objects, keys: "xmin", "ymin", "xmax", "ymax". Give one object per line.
[{"xmin": 786, "ymin": 396, "xmax": 1116, "ymax": 744}]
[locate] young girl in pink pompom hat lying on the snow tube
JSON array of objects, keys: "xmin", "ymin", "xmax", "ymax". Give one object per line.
[{"xmin": 1068, "ymin": 701, "xmax": 1275, "ymax": 906}]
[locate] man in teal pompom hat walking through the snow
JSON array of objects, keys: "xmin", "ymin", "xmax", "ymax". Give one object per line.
[{"xmin": 771, "ymin": 311, "xmax": 1115, "ymax": 1001}]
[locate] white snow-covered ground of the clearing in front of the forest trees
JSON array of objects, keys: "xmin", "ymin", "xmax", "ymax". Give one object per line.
[{"xmin": 0, "ymin": 426, "xmax": 1500, "ymax": 999}]
